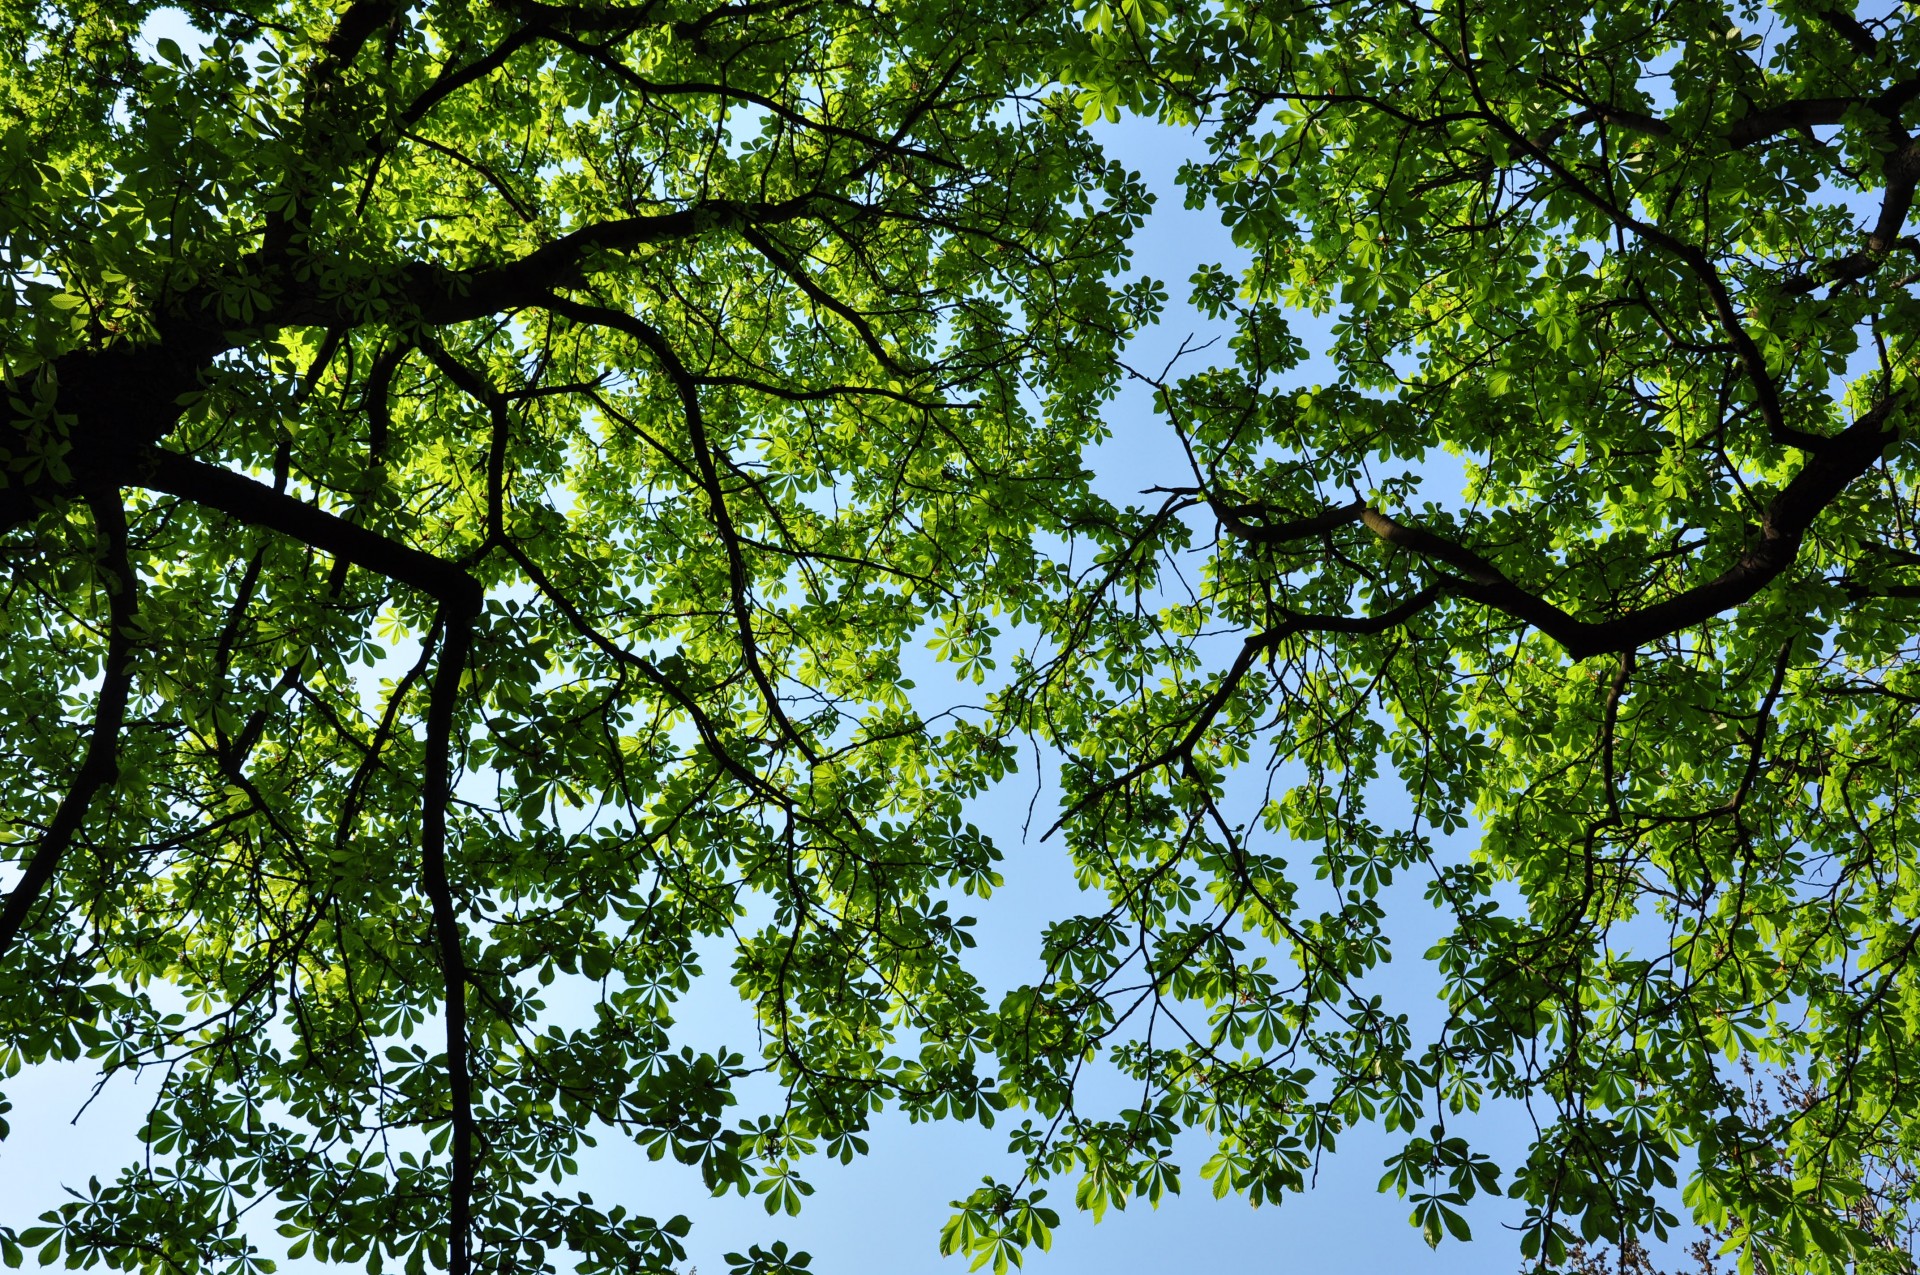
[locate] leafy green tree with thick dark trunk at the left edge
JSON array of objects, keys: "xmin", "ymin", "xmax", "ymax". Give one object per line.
[{"xmin": 0, "ymin": 0, "xmax": 1154, "ymax": 1275}]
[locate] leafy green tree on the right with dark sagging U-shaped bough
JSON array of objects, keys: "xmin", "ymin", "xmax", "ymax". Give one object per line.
[{"xmin": 952, "ymin": 0, "xmax": 1920, "ymax": 1271}]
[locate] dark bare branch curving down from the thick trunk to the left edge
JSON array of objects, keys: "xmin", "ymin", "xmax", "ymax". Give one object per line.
[{"xmin": 0, "ymin": 492, "xmax": 140, "ymax": 958}]
